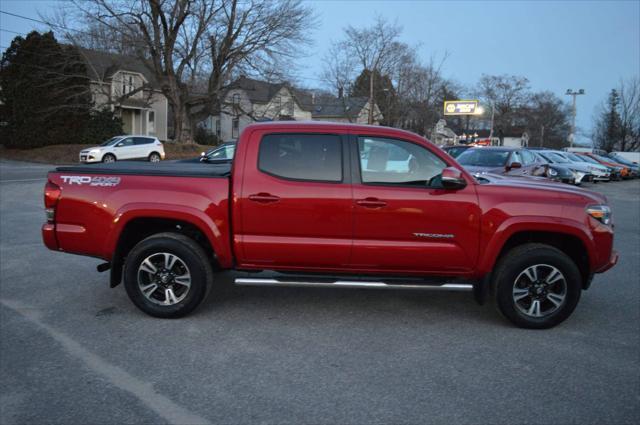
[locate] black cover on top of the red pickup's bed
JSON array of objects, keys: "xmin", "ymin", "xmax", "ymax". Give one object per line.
[{"xmin": 56, "ymin": 161, "xmax": 231, "ymax": 177}]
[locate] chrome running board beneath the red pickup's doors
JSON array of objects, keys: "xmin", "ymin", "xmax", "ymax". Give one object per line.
[{"xmin": 234, "ymin": 278, "xmax": 473, "ymax": 291}]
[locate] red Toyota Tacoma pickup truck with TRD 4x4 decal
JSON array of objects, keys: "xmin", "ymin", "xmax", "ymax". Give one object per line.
[{"xmin": 42, "ymin": 122, "xmax": 617, "ymax": 328}]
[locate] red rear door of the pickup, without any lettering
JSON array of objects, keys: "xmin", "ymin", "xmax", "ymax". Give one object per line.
[{"xmin": 234, "ymin": 131, "xmax": 353, "ymax": 270}]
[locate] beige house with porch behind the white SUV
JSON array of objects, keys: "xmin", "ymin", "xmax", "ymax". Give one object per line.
[{"xmin": 79, "ymin": 48, "xmax": 168, "ymax": 140}]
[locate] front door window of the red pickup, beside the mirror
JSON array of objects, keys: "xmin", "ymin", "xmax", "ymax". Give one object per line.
[{"xmin": 358, "ymin": 137, "xmax": 447, "ymax": 186}]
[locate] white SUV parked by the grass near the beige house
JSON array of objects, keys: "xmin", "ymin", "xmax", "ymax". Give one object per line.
[{"xmin": 80, "ymin": 136, "xmax": 164, "ymax": 162}]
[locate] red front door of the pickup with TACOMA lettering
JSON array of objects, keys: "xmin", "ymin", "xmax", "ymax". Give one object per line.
[{"xmin": 351, "ymin": 136, "xmax": 480, "ymax": 274}]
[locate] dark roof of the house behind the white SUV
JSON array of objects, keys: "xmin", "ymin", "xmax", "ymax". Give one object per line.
[{"xmin": 78, "ymin": 47, "xmax": 157, "ymax": 86}]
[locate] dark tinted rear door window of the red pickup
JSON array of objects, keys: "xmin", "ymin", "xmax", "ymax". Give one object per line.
[{"xmin": 258, "ymin": 134, "xmax": 342, "ymax": 182}]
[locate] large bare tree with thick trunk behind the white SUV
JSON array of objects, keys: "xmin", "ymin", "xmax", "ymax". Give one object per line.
[{"xmin": 55, "ymin": 0, "xmax": 314, "ymax": 141}]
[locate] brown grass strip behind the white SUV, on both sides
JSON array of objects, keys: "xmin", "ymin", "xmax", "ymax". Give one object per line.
[{"xmin": 0, "ymin": 142, "xmax": 213, "ymax": 164}]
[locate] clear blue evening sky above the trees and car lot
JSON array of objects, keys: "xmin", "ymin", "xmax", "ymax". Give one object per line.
[{"xmin": 0, "ymin": 0, "xmax": 640, "ymax": 144}]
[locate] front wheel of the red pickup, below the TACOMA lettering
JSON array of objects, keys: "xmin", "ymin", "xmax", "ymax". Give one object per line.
[{"xmin": 492, "ymin": 243, "xmax": 582, "ymax": 329}]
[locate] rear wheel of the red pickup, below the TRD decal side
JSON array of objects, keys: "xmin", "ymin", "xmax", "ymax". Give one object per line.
[{"xmin": 124, "ymin": 233, "xmax": 213, "ymax": 318}]
